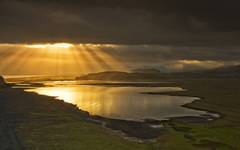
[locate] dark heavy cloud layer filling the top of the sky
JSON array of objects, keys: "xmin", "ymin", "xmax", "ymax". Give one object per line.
[{"xmin": 0, "ymin": 0, "xmax": 240, "ymax": 46}]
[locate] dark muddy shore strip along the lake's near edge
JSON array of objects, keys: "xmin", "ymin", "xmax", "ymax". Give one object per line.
[{"xmin": 16, "ymin": 83, "xmax": 218, "ymax": 141}]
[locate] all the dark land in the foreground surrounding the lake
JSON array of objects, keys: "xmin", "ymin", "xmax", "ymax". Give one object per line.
[{"xmin": 0, "ymin": 78, "xmax": 240, "ymax": 150}]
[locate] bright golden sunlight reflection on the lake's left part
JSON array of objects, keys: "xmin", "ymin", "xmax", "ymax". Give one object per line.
[{"xmin": 27, "ymin": 86, "xmax": 121, "ymax": 115}]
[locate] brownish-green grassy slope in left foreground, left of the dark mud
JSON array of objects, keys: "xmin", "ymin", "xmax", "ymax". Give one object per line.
[{"xmin": 0, "ymin": 88, "xmax": 156, "ymax": 150}]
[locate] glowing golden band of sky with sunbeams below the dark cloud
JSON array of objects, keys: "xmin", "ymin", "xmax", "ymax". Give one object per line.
[{"xmin": 0, "ymin": 42, "xmax": 237, "ymax": 75}]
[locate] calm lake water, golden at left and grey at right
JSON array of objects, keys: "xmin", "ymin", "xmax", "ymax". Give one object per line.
[{"xmin": 23, "ymin": 82, "xmax": 210, "ymax": 120}]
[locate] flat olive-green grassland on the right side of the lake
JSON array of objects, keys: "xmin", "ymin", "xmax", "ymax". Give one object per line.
[{"xmin": 156, "ymin": 78, "xmax": 240, "ymax": 150}]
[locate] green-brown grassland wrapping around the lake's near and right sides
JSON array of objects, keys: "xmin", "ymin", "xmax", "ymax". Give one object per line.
[{"xmin": 7, "ymin": 79, "xmax": 240, "ymax": 150}]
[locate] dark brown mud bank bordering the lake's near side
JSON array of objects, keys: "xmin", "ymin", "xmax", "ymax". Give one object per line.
[{"xmin": 0, "ymin": 84, "xmax": 218, "ymax": 141}]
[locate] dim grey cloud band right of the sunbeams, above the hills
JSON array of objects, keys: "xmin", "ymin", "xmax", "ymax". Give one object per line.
[{"xmin": 96, "ymin": 45, "xmax": 240, "ymax": 72}]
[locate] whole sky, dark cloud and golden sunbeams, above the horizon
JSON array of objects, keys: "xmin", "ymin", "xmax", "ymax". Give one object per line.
[{"xmin": 0, "ymin": 0, "xmax": 240, "ymax": 74}]
